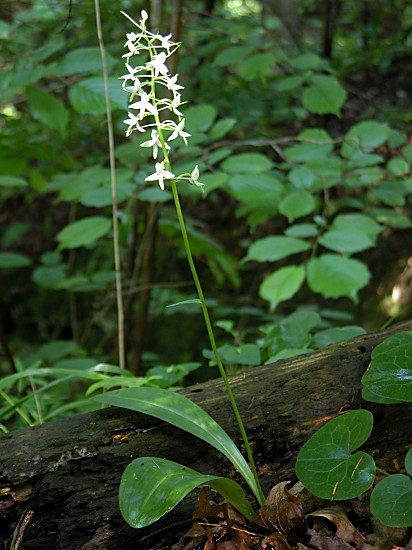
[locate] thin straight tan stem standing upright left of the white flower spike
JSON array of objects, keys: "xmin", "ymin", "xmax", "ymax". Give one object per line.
[{"xmin": 94, "ymin": 0, "xmax": 126, "ymax": 369}]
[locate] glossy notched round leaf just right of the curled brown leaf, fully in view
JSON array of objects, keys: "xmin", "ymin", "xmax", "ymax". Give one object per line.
[{"xmin": 295, "ymin": 410, "xmax": 375, "ymax": 500}]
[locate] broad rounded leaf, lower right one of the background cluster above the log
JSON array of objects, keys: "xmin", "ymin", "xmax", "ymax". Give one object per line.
[{"xmin": 307, "ymin": 254, "xmax": 370, "ymax": 300}]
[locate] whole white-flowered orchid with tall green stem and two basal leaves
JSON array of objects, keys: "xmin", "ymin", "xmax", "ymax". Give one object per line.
[{"xmin": 96, "ymin": 11, "xmax": 265, "ymax": 527}]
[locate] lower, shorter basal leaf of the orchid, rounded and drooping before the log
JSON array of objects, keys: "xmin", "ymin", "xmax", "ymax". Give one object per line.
[{"xmin": 119, "ymin": 457, "xmax": 256, "ymax": 528}]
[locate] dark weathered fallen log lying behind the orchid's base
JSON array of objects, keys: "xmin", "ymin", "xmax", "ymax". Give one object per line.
[{"xmin": 0, "ymin": 321, "xmax": 412, "ymax": 550}]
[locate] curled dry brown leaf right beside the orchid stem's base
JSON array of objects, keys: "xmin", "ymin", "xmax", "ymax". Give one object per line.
[{"xmin": 258, "ymin": 481, "xmax": 305, "ymax": 535}]
